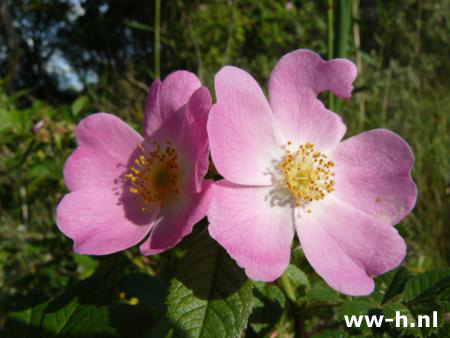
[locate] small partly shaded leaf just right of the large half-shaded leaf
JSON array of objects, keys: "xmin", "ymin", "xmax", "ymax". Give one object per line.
[{"xmin": 249, "ymin": 282, "xmax": 286, "ymax": 336}]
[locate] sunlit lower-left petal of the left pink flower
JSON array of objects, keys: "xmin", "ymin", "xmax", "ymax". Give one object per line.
[{"xmin": 56, "ymin": 188, "xmax": 159, "ymax": 255}]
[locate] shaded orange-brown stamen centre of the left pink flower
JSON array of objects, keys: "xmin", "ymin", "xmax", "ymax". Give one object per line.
[{"xmin": 125, "ymin": 141, "xmax": 179, "ymax": 207}]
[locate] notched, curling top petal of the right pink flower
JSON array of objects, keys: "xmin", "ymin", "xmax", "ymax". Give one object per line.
[{"xmin": 269, "ymin": 49, "xmax": 357, "ymax": 151}]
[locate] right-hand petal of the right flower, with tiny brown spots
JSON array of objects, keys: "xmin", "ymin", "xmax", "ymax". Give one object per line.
[{"xmin": 334, "ymin": 129, "xmax": 417, "ymax": 224}]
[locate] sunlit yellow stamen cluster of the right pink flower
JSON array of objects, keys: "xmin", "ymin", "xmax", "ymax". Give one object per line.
[{"xmin": 278, "ymin": 141, "xmax": 334, "ymax": 212}]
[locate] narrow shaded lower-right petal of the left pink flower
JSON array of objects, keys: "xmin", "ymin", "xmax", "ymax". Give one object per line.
[{"xmin": 140, "ymin": 180, "xmax": 213, "ymax": 255}]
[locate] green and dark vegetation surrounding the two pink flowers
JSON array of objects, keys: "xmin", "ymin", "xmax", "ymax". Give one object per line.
[{"xmin": 0, "ymin": 0, "xmax": 450, "ymax": 337}]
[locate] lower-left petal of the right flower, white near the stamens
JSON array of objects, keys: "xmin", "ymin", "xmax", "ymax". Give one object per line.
[{"xmin": 208, "ymin": 180, "xmax": 294, "ymax": 282}]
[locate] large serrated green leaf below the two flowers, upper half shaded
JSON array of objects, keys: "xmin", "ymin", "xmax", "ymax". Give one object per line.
[{"xmin": 167, "ymin": 231, "xmax": 252, "ymax": 337}]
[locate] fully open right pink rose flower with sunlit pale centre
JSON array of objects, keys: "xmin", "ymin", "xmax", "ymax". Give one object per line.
[{"xmin": 207, "ymin": 50, "xmax": 417, "ymax": 295}]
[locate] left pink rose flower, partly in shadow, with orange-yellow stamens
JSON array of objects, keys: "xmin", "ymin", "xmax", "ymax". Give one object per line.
[{"xmin": 56, "ymin": 71, "xmax": 212, "ymax": 255}]
